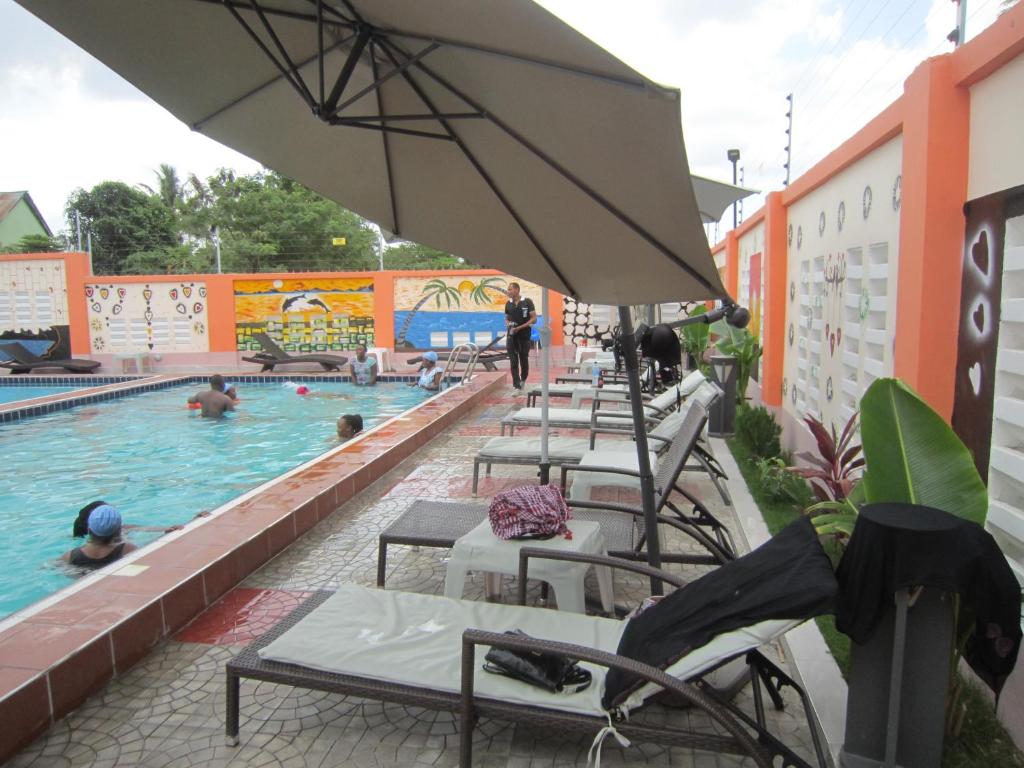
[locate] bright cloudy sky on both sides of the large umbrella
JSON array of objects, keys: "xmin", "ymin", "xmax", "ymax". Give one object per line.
[{"xmin": 0, "ymin": 0, "xmax": 999, "ymax": 231}]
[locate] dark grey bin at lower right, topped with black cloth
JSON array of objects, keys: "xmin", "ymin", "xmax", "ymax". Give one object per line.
[{"xmin": 837, "ymin": 504, "xmax": 963, "ymax": 768}]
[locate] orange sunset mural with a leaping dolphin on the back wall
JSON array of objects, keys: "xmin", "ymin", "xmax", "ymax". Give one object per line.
[{"xmin": 234, "ymin": 278, "xmax": 374, "ymax": 352}]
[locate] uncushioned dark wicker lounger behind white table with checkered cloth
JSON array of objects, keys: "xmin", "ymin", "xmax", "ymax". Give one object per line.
[{"xmin": 377, "ymin": 402, "xmax": 735, "ymax": 587}]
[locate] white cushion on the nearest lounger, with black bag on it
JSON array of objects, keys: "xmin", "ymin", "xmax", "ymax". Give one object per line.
[{"xmin": 259, "ymin": 584, "xmax": 801, "ymax": 717}]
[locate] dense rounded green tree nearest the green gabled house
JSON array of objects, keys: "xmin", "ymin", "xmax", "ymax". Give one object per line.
[{"xmin": 65, "ymin": 181, "xmax": 178, "ymax": 274}]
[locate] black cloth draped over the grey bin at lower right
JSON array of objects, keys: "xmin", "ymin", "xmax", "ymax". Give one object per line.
[{"xmin": 836, "ymin": 504, "xmax": 1021, "ymax": 692}]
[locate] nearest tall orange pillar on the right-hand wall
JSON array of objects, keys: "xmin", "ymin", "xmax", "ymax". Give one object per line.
[{"xmin": 894, "ymin": 55, "xmax": 971, "ymax": 421}]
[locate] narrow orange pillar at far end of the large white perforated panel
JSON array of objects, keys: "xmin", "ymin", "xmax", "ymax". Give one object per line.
[{"xmin": 761, "ymin": 191, "xmax": 788, "ymax": 406}]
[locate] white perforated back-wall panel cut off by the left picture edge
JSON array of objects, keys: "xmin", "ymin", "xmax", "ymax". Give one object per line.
[{"xmin": 0, "ymin": 258, "xmax": 71, "ymax": 356}]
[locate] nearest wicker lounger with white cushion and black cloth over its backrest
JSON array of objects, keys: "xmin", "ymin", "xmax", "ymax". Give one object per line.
[{"xmin": 225, "ymin": 518, "xmax": 837, "ymax": 768}]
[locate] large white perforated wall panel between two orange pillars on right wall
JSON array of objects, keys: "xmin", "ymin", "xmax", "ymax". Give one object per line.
[{"xmin": 782, "ymin": 137, "xmax": 903, "ymax": 427}]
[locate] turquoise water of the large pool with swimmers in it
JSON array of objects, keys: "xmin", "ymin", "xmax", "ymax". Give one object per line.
[{"xmin": 0, "ymin": 382, "xmax": 428, "ymax": 617}]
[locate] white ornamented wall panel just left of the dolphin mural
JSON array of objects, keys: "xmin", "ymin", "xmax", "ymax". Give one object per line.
[{"xmin": 85, "ymin": 281, "xmax": 210, "ymax": 354}]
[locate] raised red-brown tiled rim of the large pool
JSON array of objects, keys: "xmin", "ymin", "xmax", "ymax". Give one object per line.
[{"xmin": 0, "ymin": 373, "xmax": 507, "ymax": 763}]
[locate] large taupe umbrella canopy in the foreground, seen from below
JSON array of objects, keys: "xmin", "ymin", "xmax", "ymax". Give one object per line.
[{"xmin": 17, "ymin": 0, "xmax": 725, "ymax": 305}]
